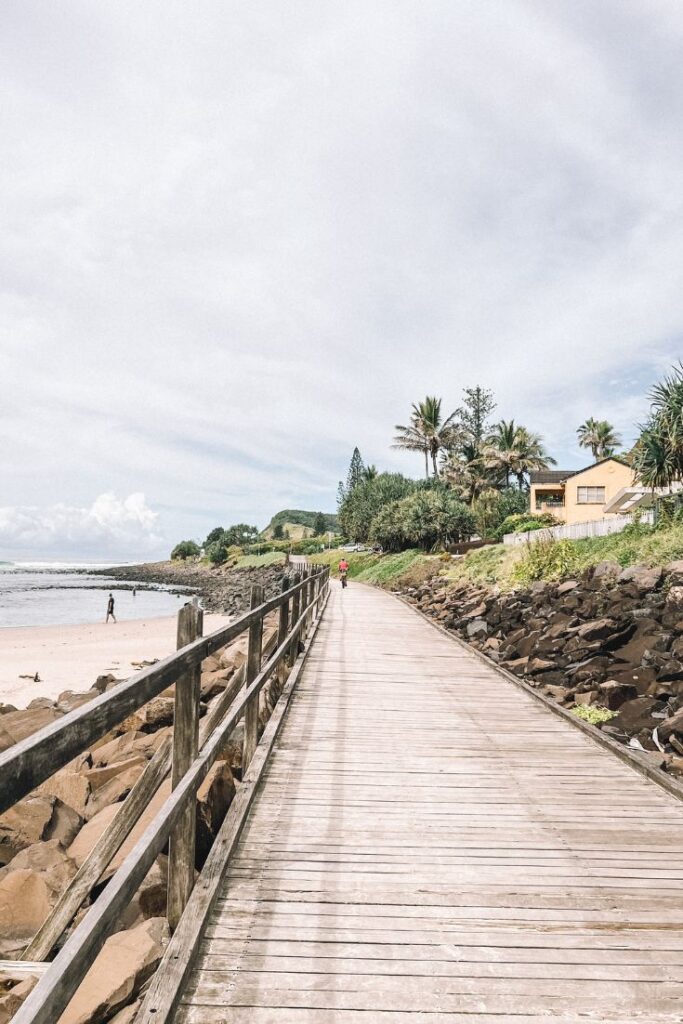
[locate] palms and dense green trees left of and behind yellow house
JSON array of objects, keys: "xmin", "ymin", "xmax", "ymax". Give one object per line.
[{"xmin": 338, "ymin": 386, "xmax": 634, "ymax": 551}]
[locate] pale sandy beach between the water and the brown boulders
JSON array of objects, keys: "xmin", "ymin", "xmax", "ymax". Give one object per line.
[{"xmin": 0, "ymin": 614, "xmax": 228, "ymax": 708}]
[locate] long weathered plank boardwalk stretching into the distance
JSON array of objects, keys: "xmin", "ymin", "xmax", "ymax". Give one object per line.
[{"xmin": 175, "ymin": 586, "xmax": 683, "ymax": 1024}]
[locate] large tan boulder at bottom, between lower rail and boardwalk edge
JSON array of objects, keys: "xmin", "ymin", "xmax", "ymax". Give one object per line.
[{"xmin": 57, "ymin": 918, "xmax": 170, "ymax": 1024}]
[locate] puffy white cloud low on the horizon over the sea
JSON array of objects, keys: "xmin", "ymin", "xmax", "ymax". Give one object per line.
[{"xmin": 0, "ymin": 493, "xmax": 163, "ymax": 558}]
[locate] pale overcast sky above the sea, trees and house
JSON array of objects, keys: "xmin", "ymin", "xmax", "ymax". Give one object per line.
[{"xmin": 0, "ymin": 0, "xmax": 683, "ymax": 558}]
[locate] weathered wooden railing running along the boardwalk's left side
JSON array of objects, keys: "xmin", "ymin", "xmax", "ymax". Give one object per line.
[{"xmin": 0, "ymin": 566, "xmax": 330, "ymax": 1024}]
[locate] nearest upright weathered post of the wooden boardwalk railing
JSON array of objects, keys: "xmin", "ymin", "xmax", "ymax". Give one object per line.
[{"xmin": 167, "ymin": 602, "xmax": 204, "ymax": 931}]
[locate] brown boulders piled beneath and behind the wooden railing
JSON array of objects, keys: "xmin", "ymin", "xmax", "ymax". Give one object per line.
[{"xmin": 0, "ymin": 615, "xmax": 280, "ymax": 1024}]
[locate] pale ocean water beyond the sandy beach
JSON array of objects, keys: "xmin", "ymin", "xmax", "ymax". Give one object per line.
[{"xmin": 0, "ymin": 563, "xmax": 187, "ymax": 629}]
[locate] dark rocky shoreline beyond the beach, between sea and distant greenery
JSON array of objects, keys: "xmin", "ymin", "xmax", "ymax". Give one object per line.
[{"xmin": 88, "ymin": 561, "xmax": 285, "ymax": 615}]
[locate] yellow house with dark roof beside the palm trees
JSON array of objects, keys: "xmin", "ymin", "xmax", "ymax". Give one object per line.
[{"xmin": 529, "ymin": 456, "xmax": 635, "ymax": 525}]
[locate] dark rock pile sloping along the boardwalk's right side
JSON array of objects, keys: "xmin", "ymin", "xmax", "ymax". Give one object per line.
[{"xmin": 404, "ymin": 561, "xmax": 683, "ymax": 775}]
